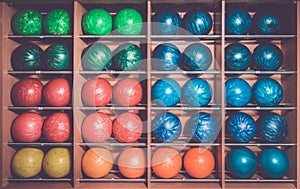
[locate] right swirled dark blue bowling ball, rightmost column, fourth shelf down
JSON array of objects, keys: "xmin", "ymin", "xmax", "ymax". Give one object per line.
[{"xmin": 257, "ymin": 113, "xmax": 288, "ymax": 142}]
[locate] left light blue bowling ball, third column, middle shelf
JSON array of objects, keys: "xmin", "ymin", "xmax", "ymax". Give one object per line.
[{"xmin": 151, "ymin": 78, "xmax": 181, "ymax": 106}]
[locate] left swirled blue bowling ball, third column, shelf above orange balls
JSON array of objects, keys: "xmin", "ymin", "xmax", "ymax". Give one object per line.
[{"xmin": 152, "ymin": 112, "xmax": 182, "ymax": 142}]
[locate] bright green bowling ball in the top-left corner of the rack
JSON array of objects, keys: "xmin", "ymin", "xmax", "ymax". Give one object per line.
[{"xmin": 11, "ymin": 9, "xmax": 42, "ymax": 35}]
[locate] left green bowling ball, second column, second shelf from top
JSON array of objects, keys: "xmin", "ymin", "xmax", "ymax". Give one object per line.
[{"xmin": 81, "ymin": 43, "xmax": 112, "ymax": 71}]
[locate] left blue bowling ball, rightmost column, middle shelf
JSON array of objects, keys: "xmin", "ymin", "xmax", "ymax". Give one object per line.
[{"xmin": 225, "ymin": 78, "xmax": 252, "ymax": 106}]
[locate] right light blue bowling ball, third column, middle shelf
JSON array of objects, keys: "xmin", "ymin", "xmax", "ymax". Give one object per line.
[{"xmin": 183, "ymin": 78, "xmax": 212, "ymax": 106}]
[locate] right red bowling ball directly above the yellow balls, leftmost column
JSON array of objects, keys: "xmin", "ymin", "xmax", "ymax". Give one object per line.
[{"xmin": 43, "ymin": 112, "xmax": 71, "ymax": 142}]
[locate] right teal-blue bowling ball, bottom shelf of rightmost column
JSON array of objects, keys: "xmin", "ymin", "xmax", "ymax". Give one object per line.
[{"xmin": 258, "ymin": 148, "xmax": 289, "ymax": 179}]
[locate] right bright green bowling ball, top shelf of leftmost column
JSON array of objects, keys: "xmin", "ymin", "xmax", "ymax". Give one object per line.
[{"xmin": 43, "ymin": 9, "xmax": 71, "ymax": 35}]
